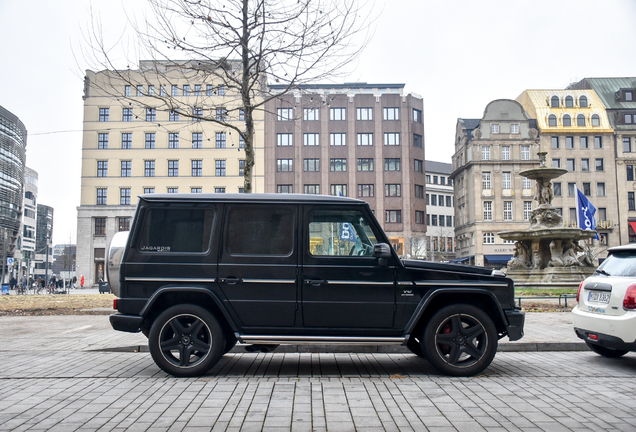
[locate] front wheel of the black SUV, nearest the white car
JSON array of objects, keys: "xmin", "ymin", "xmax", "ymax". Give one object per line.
[{"xmin": 423, "ymin": 304, "xmax": 498, "ymax": 376}]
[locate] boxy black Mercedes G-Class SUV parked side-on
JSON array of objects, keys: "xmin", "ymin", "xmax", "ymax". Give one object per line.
[{"xmin": 108, "ymin": 194, "xmax": 524, "ymax": 376}]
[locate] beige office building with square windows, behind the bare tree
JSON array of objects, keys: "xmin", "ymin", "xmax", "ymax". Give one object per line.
[{"xmin": 77, "ymin": 61, "xmax": 265, "ymax": 286}]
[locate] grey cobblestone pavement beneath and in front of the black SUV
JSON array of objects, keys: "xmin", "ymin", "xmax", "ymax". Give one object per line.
[{"xmin": 0, "ymin": 314, "xmax": 636, "ymax": 432}]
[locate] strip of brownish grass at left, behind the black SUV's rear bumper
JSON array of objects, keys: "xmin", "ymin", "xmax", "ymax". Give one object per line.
[{"xmin": 0, "ymin": 294, "xmax": 115, "ymax": 316}]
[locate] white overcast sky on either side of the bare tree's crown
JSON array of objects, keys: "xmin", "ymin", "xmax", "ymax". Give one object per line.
[{"xmin": 0, "ymin": 0, "xmax": 636, "ymax": 243}]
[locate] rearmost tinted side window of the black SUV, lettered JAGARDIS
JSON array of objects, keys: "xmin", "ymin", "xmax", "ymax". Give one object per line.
[{"xmin": 138, "ymin": 207, "xmax": 215, "ymax": 253}]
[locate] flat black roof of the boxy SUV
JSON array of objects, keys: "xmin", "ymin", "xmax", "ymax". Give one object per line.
[{"xmin": 139, "ymin": 193, "xmax": 366, "ymax": 205}]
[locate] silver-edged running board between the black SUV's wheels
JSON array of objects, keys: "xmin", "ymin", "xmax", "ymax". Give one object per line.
[{"xmin": 236, "ymin": 335, "xmax": 408, "ymax": 345}]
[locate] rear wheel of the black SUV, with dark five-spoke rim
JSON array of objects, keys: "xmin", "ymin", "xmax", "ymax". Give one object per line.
[{"xmin": 148, "ymin": 304, "xmax": 226, "ymax": 377}]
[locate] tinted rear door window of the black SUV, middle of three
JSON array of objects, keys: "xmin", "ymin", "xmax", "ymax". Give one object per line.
[{"xmin": 225, "ymin": 205, "xmax": 296, "ymax": 256}]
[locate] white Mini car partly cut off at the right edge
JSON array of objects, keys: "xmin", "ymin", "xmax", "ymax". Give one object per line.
[{"xmin": 572, "ymin": 244, "xmax": 636, "ymax": 358}]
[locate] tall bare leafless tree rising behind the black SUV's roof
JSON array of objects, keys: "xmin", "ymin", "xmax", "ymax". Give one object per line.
[{"xmin": 85, "ymin": 0, "xmax": 370, "ymax": 193}]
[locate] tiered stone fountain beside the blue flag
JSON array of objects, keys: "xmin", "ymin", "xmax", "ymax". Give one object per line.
[{"xmin": 498, "ymin": 152, "xmax": 596, "ymax": 288}]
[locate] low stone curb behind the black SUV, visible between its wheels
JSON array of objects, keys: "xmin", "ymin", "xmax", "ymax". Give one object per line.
[{"xmin": 90, "ymin": 342, "xmax": 589, "ymax": 354}]
